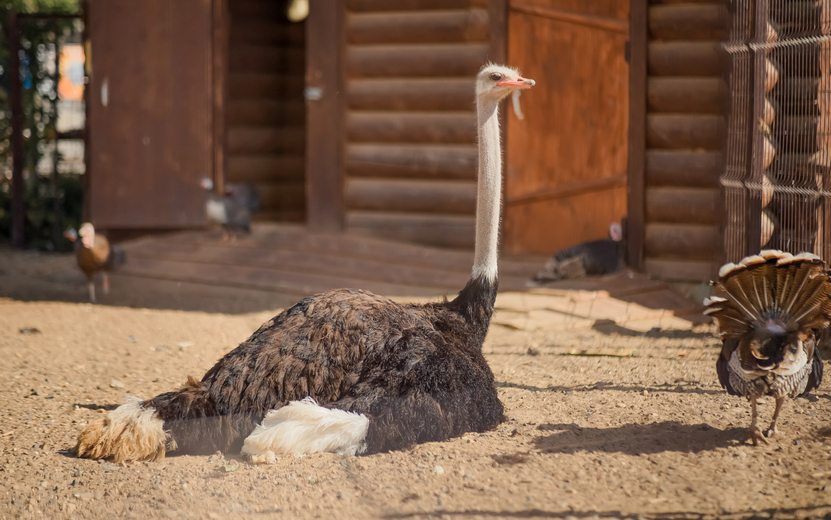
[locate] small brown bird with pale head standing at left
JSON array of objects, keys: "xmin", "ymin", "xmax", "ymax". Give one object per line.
[{"xmin": 64, "ymin": 222, "xmax": 126, "ymax": 303}]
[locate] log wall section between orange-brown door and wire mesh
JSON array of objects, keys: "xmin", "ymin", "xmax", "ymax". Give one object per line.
[{"xmin": 630, "ymin": 0, "xmax": 726, "ymax": 281}]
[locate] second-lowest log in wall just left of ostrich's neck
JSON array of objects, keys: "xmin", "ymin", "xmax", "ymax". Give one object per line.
[{"xmin": 345, "ymin": 179, "xmax": 476, "ymax": 215}]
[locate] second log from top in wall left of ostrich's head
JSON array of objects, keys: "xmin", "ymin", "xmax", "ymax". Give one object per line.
[{"xmin": 346, "ymin": 9, "xmax": 488, "ymax": 44}]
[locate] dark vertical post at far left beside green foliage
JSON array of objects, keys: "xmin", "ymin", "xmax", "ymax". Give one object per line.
[{"xmin": 7, "ymin": 11, "xmax": 26, "ymax": 249}]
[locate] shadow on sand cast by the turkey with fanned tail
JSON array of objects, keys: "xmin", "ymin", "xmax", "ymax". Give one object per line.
[{"xmin": 534, "ymin": 421, "xmax": 747, "ymax": 455}]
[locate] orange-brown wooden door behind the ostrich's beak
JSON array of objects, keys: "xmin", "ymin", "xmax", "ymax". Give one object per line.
[{"xmin": 503, "ymin": 0, "xmax": 629, "ymax": 254}]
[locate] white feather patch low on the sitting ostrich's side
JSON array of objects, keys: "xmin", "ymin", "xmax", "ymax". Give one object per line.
[{"xmin": 242, "ymin": 397, "xmax": 369, "ymax": 462}]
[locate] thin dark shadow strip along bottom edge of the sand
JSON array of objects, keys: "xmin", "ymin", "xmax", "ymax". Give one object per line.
[{"xmin": 381, "ymin": 505, "xmax": 828, "ymax": 520}]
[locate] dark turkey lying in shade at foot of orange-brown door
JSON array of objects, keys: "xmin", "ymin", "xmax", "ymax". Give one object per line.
[{"xmin": 534, "ymin": 222, "xmax": 624, "ymax": 283}]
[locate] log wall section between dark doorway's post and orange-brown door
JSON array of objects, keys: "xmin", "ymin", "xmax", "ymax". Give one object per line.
[{"xmin": 343, "ymin": 0, "xmax": 498, "ymax": 248}]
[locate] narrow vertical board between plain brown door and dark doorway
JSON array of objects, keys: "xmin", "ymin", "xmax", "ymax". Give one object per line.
[{"xmin": 211, "ymin": 0, "xmax": 230, "ymax": 193}]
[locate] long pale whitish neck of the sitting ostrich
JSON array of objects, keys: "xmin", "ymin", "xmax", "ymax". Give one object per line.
[{"xmin": 472, "ymin": 96, "xmax": 502, "ymax": 282}]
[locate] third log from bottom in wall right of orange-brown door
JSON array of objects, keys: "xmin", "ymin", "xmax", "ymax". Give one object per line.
[{"xmin": 646, "ymin": 187, "xmax": 721, "ymax": 225}]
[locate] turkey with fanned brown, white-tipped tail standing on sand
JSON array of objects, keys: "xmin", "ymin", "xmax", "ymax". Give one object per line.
[{"xmin": 704, "ymin": 250, "xmax": 831, "ymax": 445}]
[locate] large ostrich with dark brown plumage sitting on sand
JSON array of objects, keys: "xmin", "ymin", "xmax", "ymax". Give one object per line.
[{"xmin": 75, "ymin": 64, "xmax": 534, "ymax": 462}]
